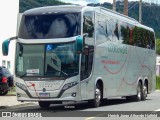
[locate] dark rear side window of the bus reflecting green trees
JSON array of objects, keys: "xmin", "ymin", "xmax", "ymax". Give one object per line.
[{"xmin": 120, "ymin": 22, "xmax": 155, "ymax": 50}]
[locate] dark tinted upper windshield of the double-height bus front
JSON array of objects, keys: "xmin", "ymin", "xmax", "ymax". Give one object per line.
[{"xmin": 18, "ymin": 12, "xmax": 81, "ymax": 39}]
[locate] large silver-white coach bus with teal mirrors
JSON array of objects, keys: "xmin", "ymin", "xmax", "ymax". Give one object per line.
[{"xmin": 2, "ymin": 5, "xmax": 156, "ymax": 108}]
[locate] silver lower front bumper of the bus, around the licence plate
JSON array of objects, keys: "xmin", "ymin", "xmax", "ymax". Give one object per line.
[{"xmin": 17, "ymin": 85, "xmax": 81, "ymax": 101}]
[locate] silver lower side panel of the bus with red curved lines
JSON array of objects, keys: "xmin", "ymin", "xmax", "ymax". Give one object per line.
[{"xmin": 94, "ymin": 41, "xmax": 155, "ymax": 97}]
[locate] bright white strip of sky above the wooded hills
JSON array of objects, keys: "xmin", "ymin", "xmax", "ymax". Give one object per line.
[{"xmin": 60, "ymin": 0, "xmax": 160, "ymax": 5}]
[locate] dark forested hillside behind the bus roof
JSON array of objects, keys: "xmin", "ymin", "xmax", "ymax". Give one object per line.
[{"xmin": 20, "ymin": 0, "xmax": 160, "ymax": 38}]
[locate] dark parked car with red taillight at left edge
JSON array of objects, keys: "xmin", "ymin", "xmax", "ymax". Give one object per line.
[{"xmin": 0, "ymin": 66, "xmax": 14, "ymax": 96}]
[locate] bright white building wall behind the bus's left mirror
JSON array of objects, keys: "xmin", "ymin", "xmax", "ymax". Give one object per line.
[{"xmin": 0, "ymin": 0, "xmax": 19, "ymax": 74}]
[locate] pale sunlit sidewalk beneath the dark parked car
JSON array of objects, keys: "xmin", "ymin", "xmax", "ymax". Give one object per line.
[{"xmin": 0, "ymin": 95, "xmax": 37, "ymax": 109}]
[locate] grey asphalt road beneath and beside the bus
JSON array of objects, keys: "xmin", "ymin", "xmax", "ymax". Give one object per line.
[{"xmin": 0, "ymin": 91, "xmax": 160, "ymax": 120}]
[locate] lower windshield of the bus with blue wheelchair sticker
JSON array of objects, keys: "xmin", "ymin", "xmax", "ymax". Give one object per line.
[{"xmin": 16, "ymin": 43, "xmax": 79, "ymax": 77}]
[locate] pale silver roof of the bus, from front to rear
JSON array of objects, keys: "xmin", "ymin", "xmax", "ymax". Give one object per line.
[{"xmin": 24, "ymin": 5, "xmax": 154, "ymax": 31}]
